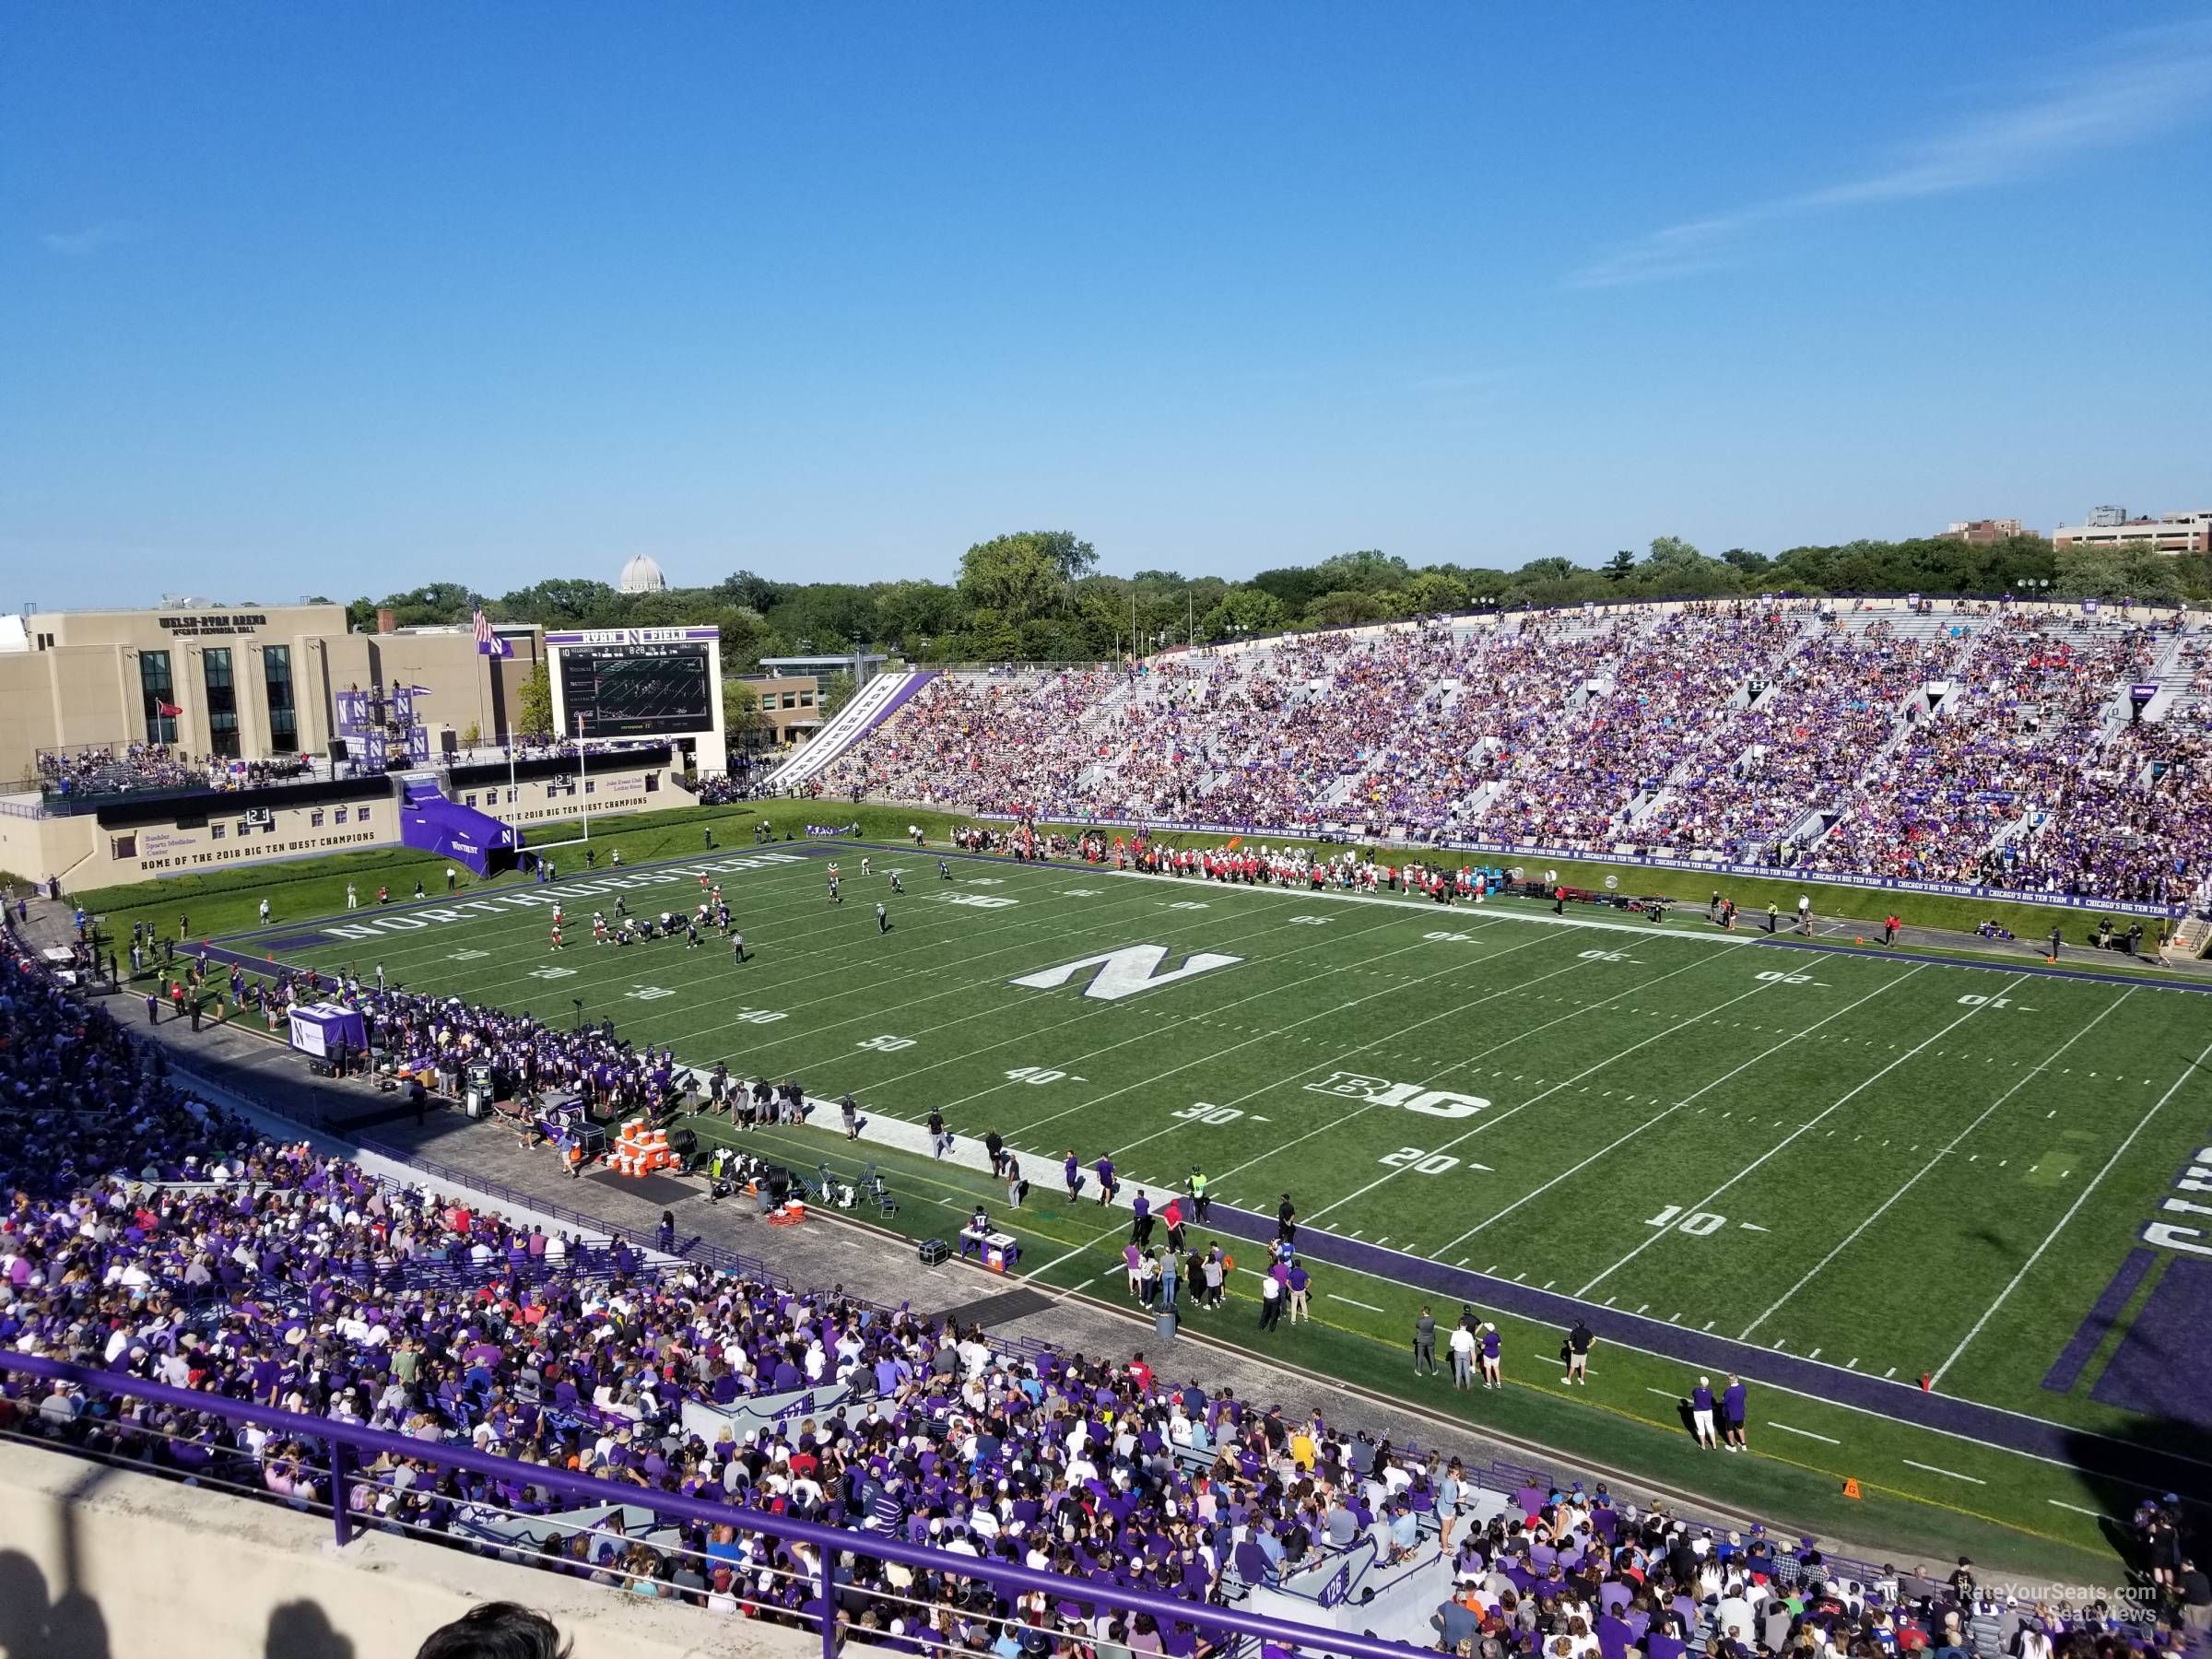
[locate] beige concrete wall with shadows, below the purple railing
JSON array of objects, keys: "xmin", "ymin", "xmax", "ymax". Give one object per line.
[{"xmin": 0, "ymin": 1444, "xmax": 818, "ymax": 1659}]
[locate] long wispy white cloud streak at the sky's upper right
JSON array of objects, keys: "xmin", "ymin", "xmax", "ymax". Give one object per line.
[{"xmin": 1566, "ymin": 24, "xmax": 2212, "ymax": 288}]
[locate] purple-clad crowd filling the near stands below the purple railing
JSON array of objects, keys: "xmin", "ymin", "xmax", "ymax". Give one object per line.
[{"xmin": 0, "ymin": 915, "xmax": 2212, "ymax": 1659}]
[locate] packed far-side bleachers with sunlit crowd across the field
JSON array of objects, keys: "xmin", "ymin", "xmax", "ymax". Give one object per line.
[{"xmin": 814, "ymin": 602, "xmax": 2212, "ymax": 905}]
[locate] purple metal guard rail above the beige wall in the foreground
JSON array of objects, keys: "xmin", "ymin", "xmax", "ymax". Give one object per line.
[{"xmin": 0, "ymin": 1351, "xmax": 1433, "ymax": 1659}]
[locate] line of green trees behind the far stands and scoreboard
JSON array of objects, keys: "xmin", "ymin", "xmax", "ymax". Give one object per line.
[{"xmin": 347, "ymin": 531, "xmax": 2212, "ymax": 673}]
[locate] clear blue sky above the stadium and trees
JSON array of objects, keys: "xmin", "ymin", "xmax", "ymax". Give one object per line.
[{"xmin": 0, "ymin": 0, "xmax": 2212, "ymax": 608}]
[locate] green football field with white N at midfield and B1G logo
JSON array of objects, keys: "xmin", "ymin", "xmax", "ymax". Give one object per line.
[{"xmin": 230, "ymin": 842, "xmax": 2212, "ymax": 1504}]
